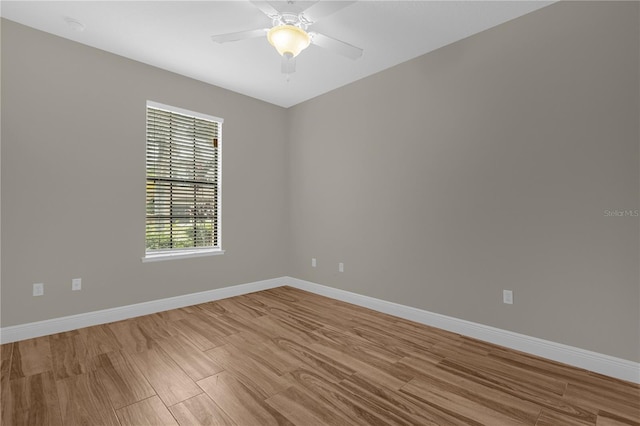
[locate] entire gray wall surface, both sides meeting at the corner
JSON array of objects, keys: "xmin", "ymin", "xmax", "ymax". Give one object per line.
[{"xmin": 2, "ymin": 2, "xmax": 640, "ymax": 361}]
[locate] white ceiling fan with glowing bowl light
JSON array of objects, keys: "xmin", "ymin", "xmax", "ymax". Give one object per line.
[{"xmin": 211, "ymin": 0, "xmax": 363, "ymax": 75}]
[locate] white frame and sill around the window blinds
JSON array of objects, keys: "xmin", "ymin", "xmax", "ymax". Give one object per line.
[{"xmin": 142, "ymin": 100, "xmax": 225, "ymax": 262}]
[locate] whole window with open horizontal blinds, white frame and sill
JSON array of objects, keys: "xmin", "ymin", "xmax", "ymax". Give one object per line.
[{"xmin": 143, "ymin": 102, "xmax": 223, "ymax": 260}]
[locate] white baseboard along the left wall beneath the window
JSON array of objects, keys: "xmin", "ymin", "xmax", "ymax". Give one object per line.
[{"xmin": 0, "ymin": 277, "xmax": 286, "ymax": 343}]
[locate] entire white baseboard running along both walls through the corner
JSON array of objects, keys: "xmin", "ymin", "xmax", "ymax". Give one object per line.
[{"xmin": 0, "ymin": 277, "xmax": 640, "ymax": 383}]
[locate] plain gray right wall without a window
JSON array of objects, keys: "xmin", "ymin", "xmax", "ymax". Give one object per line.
[{"xmin": 289, "ymin": 2, "xmax": 640, "ymax": 361}]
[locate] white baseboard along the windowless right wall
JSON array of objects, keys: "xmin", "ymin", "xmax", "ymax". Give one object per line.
[{"xmin": 286, "ymin": 277, "xmax": 640, "ymax": 383}]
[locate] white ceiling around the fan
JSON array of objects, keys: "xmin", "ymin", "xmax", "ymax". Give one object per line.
[{"xmin": 0, "ymin": 0, "xmax": 552, "ymax": 107}]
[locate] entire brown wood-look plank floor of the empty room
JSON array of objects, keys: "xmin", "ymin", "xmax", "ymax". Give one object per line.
[{"xmin": 0, "ymin": 287, "xmax": 640, "ymax": 426}]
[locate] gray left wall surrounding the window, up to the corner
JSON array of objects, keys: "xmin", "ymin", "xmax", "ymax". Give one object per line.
[{"xmin": 1, "ymin": 20, "xmax": 289, "ymax": 327}]
